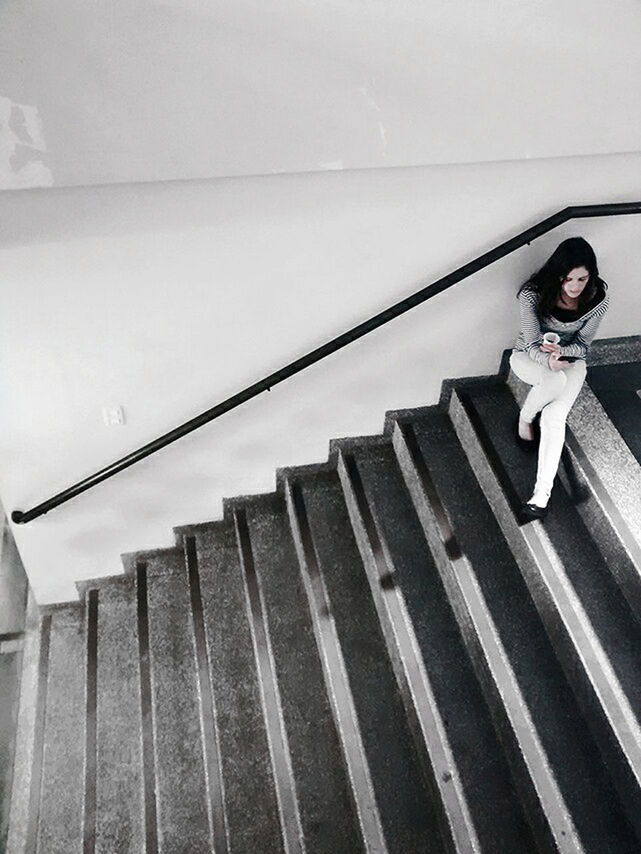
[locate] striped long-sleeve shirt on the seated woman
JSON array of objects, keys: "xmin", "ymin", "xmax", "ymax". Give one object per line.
[{"xmin": 514, "ymin": 282, "xmax": 610, "ymax": 365}]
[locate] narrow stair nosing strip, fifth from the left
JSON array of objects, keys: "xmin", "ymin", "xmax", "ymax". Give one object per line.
[{"xmin": 233, "ymin": 507, "xmax": 305, "ymax": 854}]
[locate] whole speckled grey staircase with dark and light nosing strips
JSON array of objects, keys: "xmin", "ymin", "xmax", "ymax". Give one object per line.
[{"xmin": 8, "ymin": 338, "xmax": 641, "ymax": 854}]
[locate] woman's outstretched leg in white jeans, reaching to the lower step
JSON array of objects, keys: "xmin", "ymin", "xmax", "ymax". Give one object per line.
[{"xmin": 530, "ymin": 360, "xmax": 586, "ymax": 507}]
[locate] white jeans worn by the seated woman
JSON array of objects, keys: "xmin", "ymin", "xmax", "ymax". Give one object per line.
[{"xmin": 510, "ymin": 350, "xmax": 586, "ymax": 504}]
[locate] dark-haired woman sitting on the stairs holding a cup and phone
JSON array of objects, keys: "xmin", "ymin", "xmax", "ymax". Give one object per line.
[{"xmin": 510, "ymin": 237, "xmax": 609, "ymax": 519}]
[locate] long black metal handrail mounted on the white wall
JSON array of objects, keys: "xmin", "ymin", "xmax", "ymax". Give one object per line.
[{"xmin": 11, "ymin": 202, "xmax": 641, "ymax": 524}]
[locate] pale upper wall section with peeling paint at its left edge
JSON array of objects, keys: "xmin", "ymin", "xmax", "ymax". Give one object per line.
[{"xmin": 0, "ymin": 0, "xmax": 641, "ymax": 189}]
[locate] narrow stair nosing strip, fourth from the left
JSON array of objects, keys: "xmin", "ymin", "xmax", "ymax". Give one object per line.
[{"xmin": 184, "ymin": 535, "xmax": 230, "ymax": 854}]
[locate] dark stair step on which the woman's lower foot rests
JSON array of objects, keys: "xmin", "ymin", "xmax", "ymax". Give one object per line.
[{"xmin": 451, "ymin": 383, "xmax": 641, "ymax": 835}]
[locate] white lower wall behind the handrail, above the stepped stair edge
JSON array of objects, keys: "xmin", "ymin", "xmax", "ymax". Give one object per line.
[{"xmin": 0, "ymin": 150, "xmax": 641, "ymax": 602}]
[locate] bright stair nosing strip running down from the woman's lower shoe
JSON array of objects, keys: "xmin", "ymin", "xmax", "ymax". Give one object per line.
[{"xmin": 452, "ymin": 396, "xmax": 641, "ymax": 791}]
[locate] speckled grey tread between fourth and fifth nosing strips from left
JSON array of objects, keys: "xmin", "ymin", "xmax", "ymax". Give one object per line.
[{"xmin": 186, "ymin": 522, "xmax": 284, "ymax": 854}]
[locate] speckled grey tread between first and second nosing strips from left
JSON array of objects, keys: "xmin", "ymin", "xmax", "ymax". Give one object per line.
[{"xmin": 36, "ymin": 603, "xmax": 86, "ymax": 854}]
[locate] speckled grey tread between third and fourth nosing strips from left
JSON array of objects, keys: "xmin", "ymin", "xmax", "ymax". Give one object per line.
[{"xmin": 138, "ymin": 549, "xmax": 211, "ymax": 854}]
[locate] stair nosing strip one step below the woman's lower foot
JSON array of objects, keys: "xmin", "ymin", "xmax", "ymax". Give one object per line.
[{"xmin": 394, "ymin": 424, "xmax": 584, "ymax": 852}]
